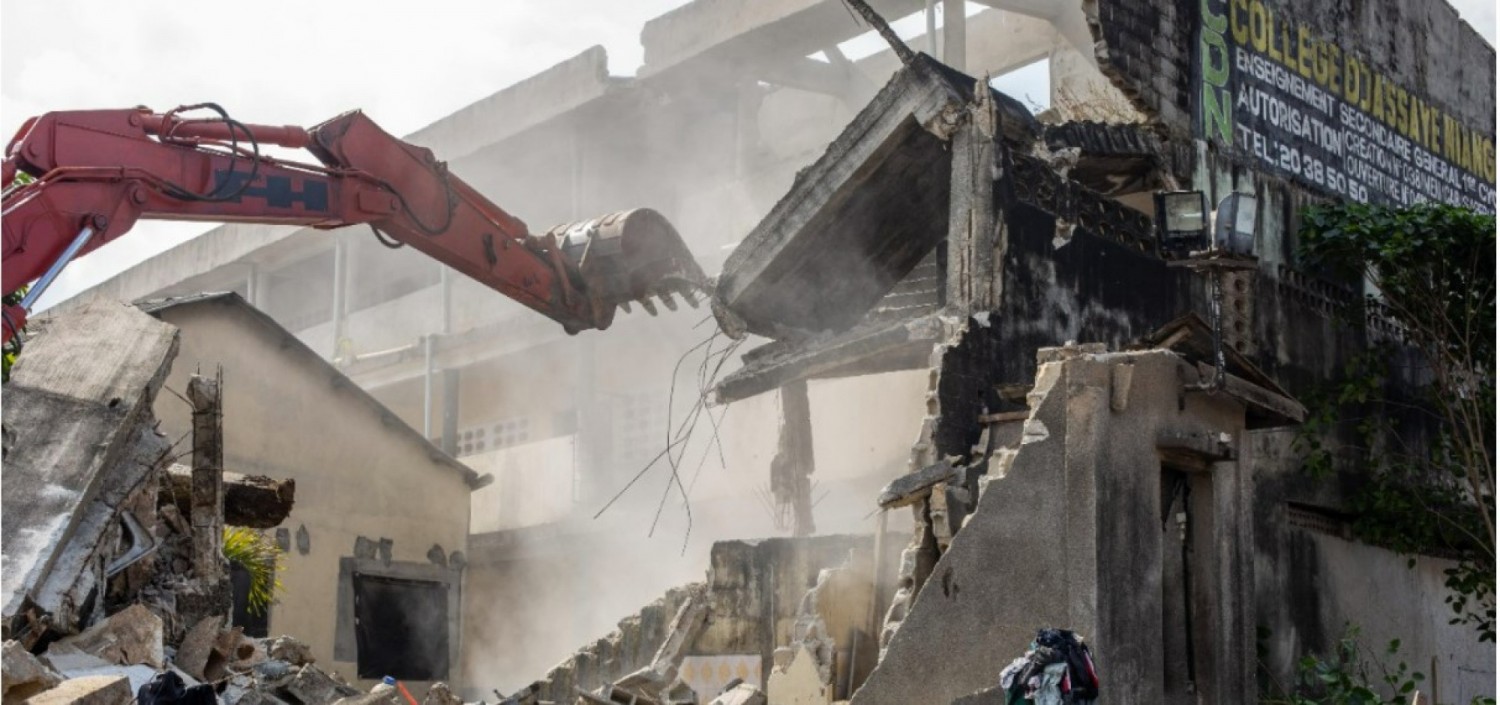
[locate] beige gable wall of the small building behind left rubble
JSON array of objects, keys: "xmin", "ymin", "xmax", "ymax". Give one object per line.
[{"xmin": 156, "ymin": 302, "xmax": 470, "ymax": 686}]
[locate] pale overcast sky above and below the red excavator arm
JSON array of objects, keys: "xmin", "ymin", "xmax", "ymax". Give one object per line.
[{"xmin": 0, "ymin": 0, "xmax": 1496, "ymax": 306}]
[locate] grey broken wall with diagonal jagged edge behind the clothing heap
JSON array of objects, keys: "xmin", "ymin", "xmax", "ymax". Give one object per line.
[{"xmin": 854, "ymin": 353, "xmax": 1254, "ymax": 705}]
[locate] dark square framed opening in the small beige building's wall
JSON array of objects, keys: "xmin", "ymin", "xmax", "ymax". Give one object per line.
[{"xmin": 354, "ymin": 573, "xmax": 449, "ymax": 681}]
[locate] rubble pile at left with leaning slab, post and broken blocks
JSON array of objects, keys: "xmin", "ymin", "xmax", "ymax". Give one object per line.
[{"xmin": 0, "ymin": 303, "xmax": 375, "ymax": 705}]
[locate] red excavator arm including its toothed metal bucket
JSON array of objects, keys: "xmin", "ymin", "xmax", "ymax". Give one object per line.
[{"xmin": 3, "ymin": 104, "xmax": 704, "ymax": 341}]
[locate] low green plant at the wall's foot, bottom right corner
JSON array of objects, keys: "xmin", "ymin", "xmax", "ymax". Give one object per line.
[{"xmin": 1262, "ymin": 626, "xmax": 1496, "ymax": 705}]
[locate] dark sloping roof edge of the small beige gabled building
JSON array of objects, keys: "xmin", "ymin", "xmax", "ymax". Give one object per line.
[{"xmin": 134, "ymin": 291, "xmax": 495, "ymax": 491}]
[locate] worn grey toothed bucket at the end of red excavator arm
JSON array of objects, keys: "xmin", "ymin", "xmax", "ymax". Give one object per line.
[{"xmin": 548, "ymin": 209, "xmax": 708, "ymax": 329}]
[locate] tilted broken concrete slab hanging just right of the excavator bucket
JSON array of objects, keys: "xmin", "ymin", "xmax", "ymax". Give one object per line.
[{"xmin": 716, "ymin": 54, "xmax": 1041, "ymax": 338}]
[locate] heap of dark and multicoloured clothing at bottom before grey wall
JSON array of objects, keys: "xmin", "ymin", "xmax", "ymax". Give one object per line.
[{"xmin": 1001, "ymin": 629, "xmax": 1100, "ymax": 705}]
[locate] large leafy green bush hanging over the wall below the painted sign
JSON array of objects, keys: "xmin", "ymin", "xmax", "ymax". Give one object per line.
[{"xmin": 1298, "ymin": 204, "xmax": 1496, "ymax": 642}]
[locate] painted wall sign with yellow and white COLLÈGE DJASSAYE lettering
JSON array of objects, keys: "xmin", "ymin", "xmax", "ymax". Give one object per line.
[{"xmin": 1193, "ymin": 0, "xmax": 1496, "ymax": 213}]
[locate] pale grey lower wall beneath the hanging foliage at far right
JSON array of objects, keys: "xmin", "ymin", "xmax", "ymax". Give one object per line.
[{"xmin": 1248, "ymin": 429, "xmax": 1496, "ymax": 702}]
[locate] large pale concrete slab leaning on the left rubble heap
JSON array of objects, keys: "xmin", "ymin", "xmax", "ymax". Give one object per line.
[{"xmin": 3, "ymin": 302, "xmax": 179, "ymax": 644}]
